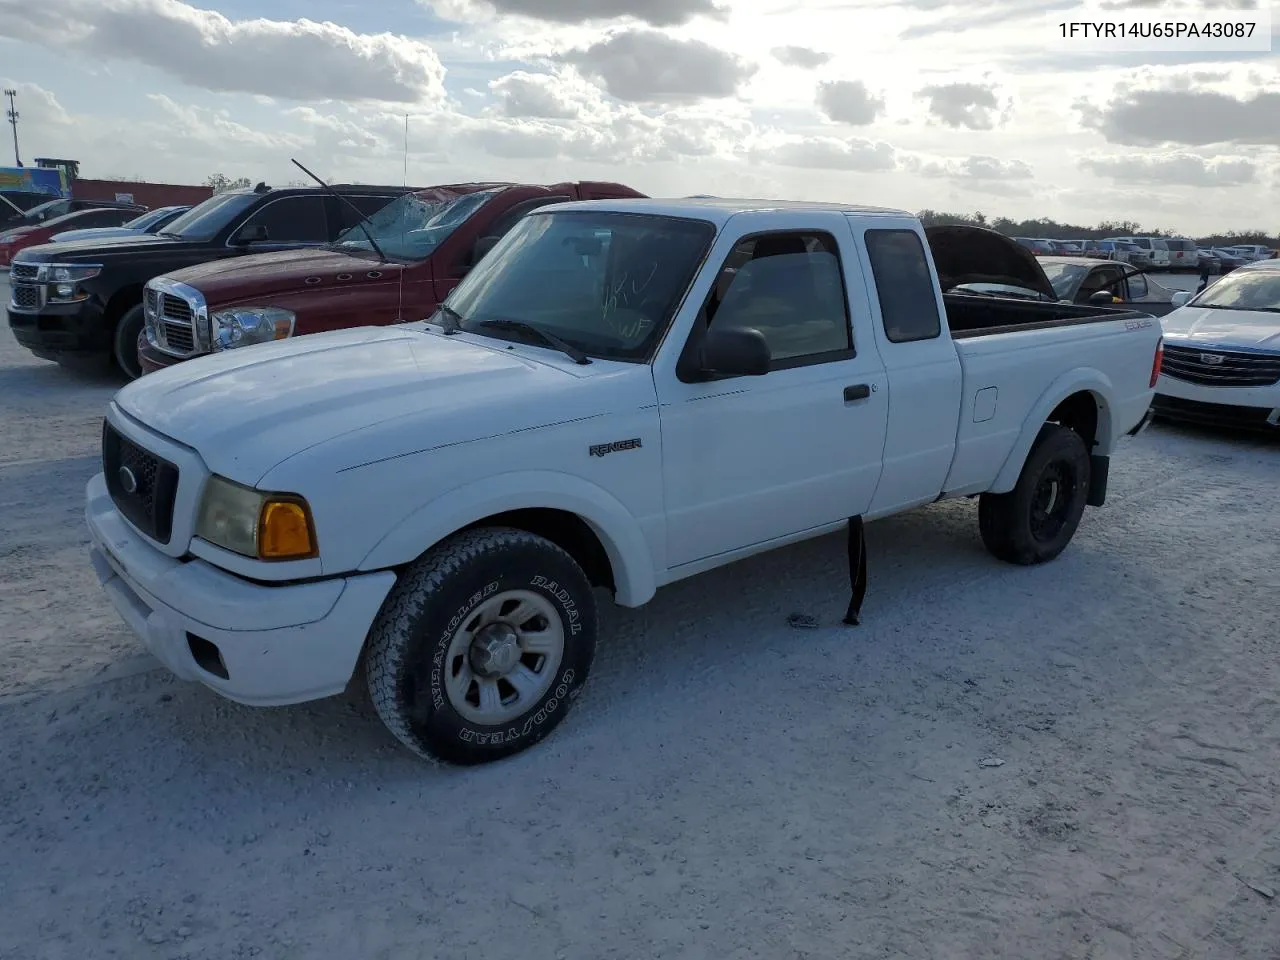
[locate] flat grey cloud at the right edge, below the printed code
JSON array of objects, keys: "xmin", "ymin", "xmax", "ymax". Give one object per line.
[{"xmin": 1075, "ymin": 90, "xmax": 1280, "ymax": 146}]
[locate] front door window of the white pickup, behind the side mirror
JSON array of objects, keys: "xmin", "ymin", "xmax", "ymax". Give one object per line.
[{"xmin": 703, "ymin": 232, "xmax": 854, "ymax": 370}]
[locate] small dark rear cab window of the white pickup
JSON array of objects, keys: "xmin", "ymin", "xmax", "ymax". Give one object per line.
[{"xmin": 865, "ymin": 230, "xmax": 942, "ymax": 343}]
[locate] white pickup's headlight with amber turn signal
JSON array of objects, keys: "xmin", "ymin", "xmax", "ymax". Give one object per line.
[{"xmin": 196, "ymin": 476, "xmax": 317, "ymax": 561}]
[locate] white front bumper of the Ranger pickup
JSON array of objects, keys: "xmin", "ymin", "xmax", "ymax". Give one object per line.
[{"xmin": 84, "ymin": 474, "xmax": 396, "ymax": 707}]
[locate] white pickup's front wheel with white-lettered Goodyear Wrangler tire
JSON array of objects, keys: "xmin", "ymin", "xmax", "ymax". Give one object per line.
[{"xmin": 366, "ymin": 527, "xmax": 596, "ymax": 765}]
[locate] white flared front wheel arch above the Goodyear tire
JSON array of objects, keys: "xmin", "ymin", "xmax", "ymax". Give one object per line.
[{"xmin": 358, "ymin": 470, "xmax": 658, "ymax": 607}]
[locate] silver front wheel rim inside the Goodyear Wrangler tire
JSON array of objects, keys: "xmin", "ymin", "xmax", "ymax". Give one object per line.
[{"xmin": 444, "ymin": 590, "xmax": 564, "ymax": 726}]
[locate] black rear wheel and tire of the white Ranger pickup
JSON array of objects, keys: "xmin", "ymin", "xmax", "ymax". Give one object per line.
[{"xmin": 978, "ymin": 424, "xmax": 1091, "ymax": 566}]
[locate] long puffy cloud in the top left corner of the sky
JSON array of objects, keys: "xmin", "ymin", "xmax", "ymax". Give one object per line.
[{"xmin": 0, "ymin": 0, "xmax": 444, "ymax": 102}]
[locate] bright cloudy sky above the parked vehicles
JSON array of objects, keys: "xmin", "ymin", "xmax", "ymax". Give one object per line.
[{"xmin": 0, "ymin": 0, "xmax": 1280, "ymax": 236}]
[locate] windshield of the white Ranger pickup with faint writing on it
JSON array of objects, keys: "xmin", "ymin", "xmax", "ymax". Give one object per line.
[{"xmin": 448, "ymin": 210, "xmax": 716, "ymax": 362}]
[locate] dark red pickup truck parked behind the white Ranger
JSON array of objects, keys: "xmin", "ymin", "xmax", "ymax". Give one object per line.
[{"xmin": 138, "ymin": 182, "xmax": 645, "ymax": 374}]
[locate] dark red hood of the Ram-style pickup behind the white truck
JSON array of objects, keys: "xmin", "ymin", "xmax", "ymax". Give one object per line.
[{"xmin": 165, "ymin": 248, "xmax": 404, "ymax": 306}]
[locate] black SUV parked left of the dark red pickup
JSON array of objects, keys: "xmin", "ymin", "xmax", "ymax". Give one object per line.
[{"xmin": 8, "ymin": 183, "xmax": 406, "ymax": 379}]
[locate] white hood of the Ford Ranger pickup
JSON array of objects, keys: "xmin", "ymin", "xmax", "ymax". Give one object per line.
[{"xmin": 114, "ymin": 324, "xmax": 588, "ymax": 484}]
